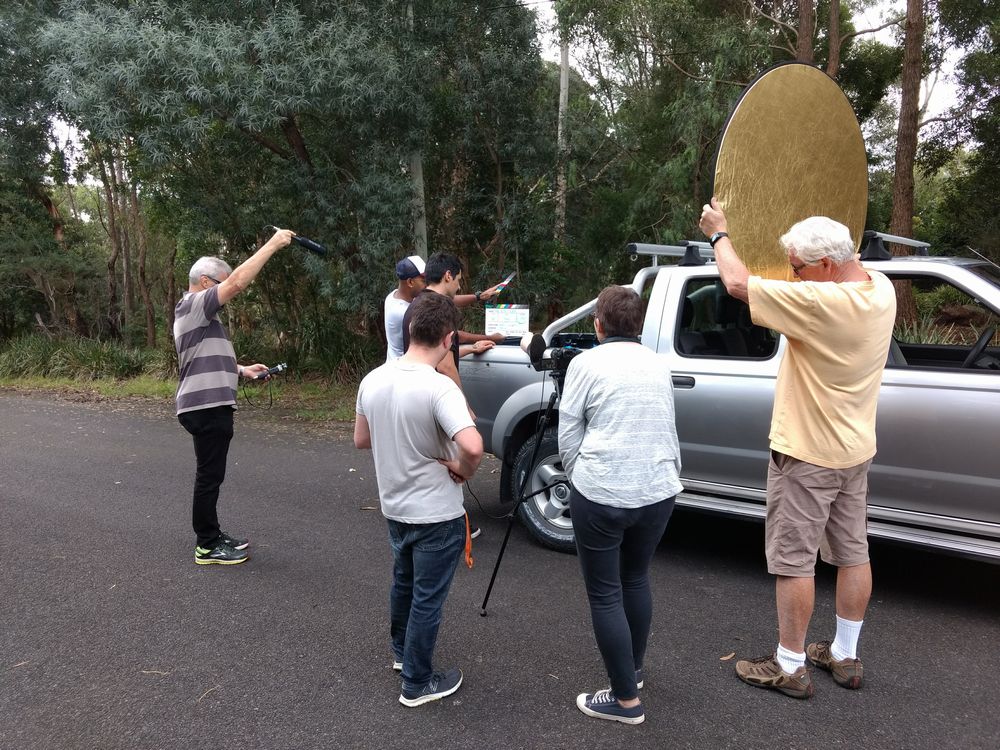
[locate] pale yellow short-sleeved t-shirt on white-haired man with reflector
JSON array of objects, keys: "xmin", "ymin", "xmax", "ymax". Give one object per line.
[{"xmin": 747, "ymin": 271, "xmax": 896, "ymax": 469}]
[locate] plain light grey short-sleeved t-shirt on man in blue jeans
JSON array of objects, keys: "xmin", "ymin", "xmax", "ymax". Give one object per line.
[{"xmin": 357, "ymin": 359, "xmax": 475, "ymax": 523}]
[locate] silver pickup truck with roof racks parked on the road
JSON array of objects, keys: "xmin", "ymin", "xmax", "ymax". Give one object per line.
[{"xmin": 460, "ymin": 238, "xmax": 1000, "ymax": 562}]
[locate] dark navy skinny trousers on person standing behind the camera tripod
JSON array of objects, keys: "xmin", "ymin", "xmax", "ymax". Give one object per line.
[{"xmin": 570, "ymin": 488, "xmax": 674, "ymax": 700}]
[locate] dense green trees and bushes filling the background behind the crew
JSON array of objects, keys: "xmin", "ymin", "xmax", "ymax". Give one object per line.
[{"xmin": 0, "ymin": 0, "xmax": 1000, "ymax": 381}]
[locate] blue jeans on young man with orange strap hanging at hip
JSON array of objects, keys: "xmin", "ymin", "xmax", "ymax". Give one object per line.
[{"xmin": 387, "ymin": 515, "xmax": 465, "ymax": 691}]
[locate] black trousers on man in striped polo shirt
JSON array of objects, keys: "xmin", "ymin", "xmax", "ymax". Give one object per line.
[{"xmin": 177, "ymin": 406, "xmax": 233, "ymax": 548}]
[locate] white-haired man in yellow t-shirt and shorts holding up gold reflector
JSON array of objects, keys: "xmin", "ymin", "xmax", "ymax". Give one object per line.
[{"xmin": 700, "ymin": 199, "xmax": 896, "ymax": 698}]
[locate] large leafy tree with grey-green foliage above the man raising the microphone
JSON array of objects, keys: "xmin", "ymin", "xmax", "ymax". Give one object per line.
[{"xmin": 43, "ymin": 0, "xmax": 564, "ymax": 358}]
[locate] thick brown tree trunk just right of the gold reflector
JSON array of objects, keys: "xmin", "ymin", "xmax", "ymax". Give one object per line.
[{"xmin": 889, "ymin": 0, "xmax": 924, "ymax": 322}]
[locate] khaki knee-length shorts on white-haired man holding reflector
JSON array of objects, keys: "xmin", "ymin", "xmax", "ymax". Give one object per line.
[{"xmin": 764, "ymin": 451, "xmax": 872, "ymax": 578}]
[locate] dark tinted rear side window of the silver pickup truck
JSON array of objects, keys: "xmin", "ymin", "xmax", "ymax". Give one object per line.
[{"xmin": 675, "ymin": 279, "xmax": 778, "ymax": 359}]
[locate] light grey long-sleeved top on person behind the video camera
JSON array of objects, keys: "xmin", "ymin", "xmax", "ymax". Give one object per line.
[{"xmin": 559, "ymin": 342, "xmax": 683, "ymax": 508}]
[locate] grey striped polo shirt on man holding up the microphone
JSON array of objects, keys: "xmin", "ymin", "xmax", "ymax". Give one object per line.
[{"xmin": 174, "ymin": 285, "xmax": 237, "ymax": 414}]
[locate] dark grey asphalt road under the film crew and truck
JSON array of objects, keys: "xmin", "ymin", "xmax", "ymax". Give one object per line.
[{"xmin": 0, "ymin": 392, "xmax": 1000, "ymax": 750}]
